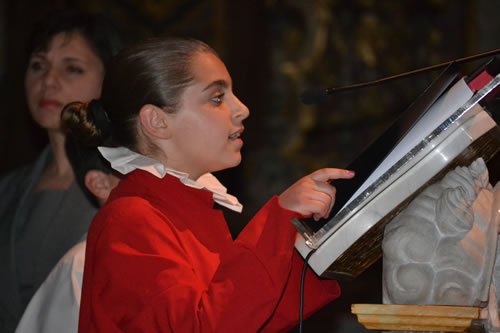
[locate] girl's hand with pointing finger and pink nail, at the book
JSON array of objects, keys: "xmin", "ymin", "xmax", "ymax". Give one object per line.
[{"xmin": 279, "ymin": 168, "xmax": 354, "ymax": 221}]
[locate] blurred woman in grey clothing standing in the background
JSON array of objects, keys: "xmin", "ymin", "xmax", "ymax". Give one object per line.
[{"xmin": 0, "ymin": 11, "xmax": 121, "ymax": 332}]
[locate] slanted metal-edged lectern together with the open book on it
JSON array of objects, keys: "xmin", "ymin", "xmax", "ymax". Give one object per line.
[{"xmin": 292, "ymin": 60, "xmax": 500, "ymax": 278}]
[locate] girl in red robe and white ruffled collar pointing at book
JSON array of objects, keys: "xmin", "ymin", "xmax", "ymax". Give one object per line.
[{"xmin": 63, "ymin": 39, "xmax": 353, "ymax": 332}]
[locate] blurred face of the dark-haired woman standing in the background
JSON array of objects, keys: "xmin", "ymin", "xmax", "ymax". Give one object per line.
[{"xmin": 25, "ymin": 32, "xmax": 104, "ymax": 130}]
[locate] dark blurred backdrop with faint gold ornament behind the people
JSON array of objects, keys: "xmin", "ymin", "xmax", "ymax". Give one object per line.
[{"xmin": 0, "ymin": 0, "xmax": 500, "ymax": 332}]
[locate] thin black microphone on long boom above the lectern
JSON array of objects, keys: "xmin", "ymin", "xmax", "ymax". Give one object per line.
[{"xmin": 300, "ymin": 49, "xmax": 500, "ymax": 105}]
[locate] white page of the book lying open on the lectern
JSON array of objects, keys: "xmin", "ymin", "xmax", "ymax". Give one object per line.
[{"xmin": 342, "ymin": 79, "xmax": 473, "ymax": 209}]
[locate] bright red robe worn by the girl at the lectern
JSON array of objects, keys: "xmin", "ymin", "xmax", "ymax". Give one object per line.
[{"xmin": 79, "ymin": 170, "xmax": 340, "ymax": 333}]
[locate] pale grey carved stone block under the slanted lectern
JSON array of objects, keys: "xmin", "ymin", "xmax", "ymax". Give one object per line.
[{"xmin": 382, "ymin": 159, "xmax": 500, "ymax": 330}]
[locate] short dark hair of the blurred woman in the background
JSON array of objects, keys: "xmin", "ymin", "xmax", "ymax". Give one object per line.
[{"xmin": 27, "ymin": 9, "xmax": 122, "ymax": 67}]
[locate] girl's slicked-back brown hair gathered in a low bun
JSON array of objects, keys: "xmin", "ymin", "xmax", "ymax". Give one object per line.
[{"xmin": 61, "ymin": 38, "xmax": 216, "ymax": 151}]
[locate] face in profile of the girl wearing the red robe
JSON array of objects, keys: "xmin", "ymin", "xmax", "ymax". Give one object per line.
[{"xmin": 166, "ymin": 53, "xmax": 249, "ymax": 179}]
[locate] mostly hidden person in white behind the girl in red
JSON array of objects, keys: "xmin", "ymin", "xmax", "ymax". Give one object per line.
[{"xmin": 16, "ymin": 133, "xmax": 120, "ymax": 333}]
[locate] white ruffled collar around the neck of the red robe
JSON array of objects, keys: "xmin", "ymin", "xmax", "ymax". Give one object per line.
[{"xmin": 97, "ymin": 147, "xmax": 243, "ymax": 213}]
